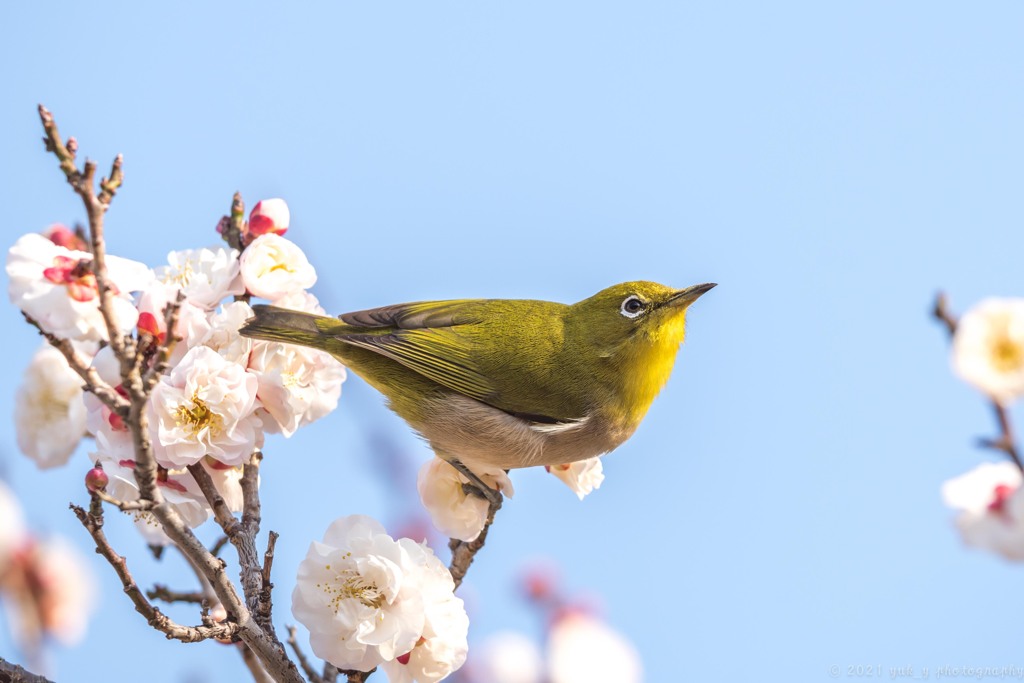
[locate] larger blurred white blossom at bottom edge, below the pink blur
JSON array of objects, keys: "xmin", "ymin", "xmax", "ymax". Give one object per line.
[{"xmin": 548, "ymin": 610, "xmax": 643, "ymax": 683}]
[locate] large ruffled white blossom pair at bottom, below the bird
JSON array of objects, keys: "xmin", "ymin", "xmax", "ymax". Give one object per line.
[{"xmin": 292, "ymin": 515, "xmax": 468, "ymax": 681}]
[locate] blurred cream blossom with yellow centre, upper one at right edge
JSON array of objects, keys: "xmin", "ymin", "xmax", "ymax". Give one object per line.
[{"xmin": 952, "ymin": 298, "xmax": 1024, "ymax": 403}]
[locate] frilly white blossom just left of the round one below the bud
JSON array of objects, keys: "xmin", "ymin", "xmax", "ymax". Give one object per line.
[{"xmin": 156, "ymin": 247, "xmax": 246, "ymax": 310}]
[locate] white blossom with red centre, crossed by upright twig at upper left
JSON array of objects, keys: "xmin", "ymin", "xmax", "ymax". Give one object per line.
[{"xmin": 7, "ymin": 233, "xmax": 153, "ymax": 340}]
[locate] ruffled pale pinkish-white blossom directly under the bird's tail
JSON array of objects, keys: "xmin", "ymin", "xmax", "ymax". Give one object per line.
[{"xmin": 249, "ymin": 341, "xmax": 345, "ymax": 436}]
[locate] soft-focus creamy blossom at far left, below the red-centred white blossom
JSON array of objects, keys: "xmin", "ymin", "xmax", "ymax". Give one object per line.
[{"xmin": 14, "ymin": 344, "xmax": 85, "ymax": 469}]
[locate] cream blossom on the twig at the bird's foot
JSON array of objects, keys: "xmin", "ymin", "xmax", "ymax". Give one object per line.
[{"xmin": 416, "ymin": 457, "xmax": 515, "ymax": 541}]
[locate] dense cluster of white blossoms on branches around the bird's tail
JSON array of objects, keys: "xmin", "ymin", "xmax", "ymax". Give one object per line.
[{"xmin": 6, "ymin": 200, "xmax": 345, "ymax": 544}]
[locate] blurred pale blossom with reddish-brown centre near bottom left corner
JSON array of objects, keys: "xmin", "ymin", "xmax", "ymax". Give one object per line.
[{"xmin": 2, "ymin": 538, "xmax": 96, "ymax": 651}]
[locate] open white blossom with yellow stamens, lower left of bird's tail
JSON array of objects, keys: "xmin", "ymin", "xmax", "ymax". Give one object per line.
[{"xmin": 148, "ymin": 346, "xmax": 263, "ymax": 469}]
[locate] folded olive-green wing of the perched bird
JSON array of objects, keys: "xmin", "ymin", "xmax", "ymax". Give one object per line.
[{"xmin": 325, "ymin": 299, "xmax": 580, "ymax": 422}]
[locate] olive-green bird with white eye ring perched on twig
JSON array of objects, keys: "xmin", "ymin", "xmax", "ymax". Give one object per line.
[{"xmin": 240, "ymin": 281, "xmax": 716, "ymax": 501}]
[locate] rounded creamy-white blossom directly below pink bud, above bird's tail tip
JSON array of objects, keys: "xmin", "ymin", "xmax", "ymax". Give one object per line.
[{"xmin": 241, "ymin": 232, "xmax": 316, "ymax": 300}]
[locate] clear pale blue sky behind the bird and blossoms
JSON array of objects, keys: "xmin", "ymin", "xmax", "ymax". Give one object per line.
[{"xmin": 0, "ymin": 2, "xmax": 1024, "ymax": 683}]
